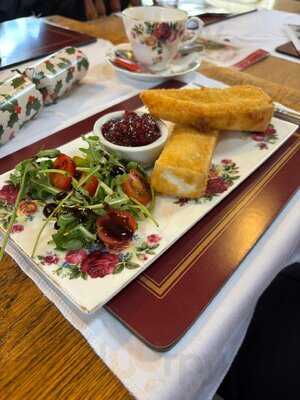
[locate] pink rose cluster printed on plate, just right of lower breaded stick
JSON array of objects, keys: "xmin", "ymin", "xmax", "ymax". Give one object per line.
[{"xmin": 175, "ymin": 159, "xmax": 240, "ymax": 207}]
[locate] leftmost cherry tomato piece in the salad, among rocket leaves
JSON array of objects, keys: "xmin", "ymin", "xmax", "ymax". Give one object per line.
[{"xmin": 50, "ymin": 154, "xmax": 76, "ymax": 190}]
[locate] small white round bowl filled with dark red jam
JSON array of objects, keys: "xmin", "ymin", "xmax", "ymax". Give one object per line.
[{"xmin": 94, "ymin": 111, "xmax": 168, "ymax": 167}]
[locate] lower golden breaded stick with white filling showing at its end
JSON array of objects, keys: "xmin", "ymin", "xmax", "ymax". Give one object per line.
[{"xmin": 151, "ymin": 125, "xmax": 218, "ymax": 198}]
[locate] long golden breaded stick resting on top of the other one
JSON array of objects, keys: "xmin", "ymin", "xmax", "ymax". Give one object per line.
[{"xmin": 141, "ymin": 85, "xmax": 273, "ymax": 132}]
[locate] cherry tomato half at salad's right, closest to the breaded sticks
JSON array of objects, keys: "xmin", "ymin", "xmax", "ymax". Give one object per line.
[{"xmin": 122, "ymin": 169, "xmax": 152, "ymax": 205}]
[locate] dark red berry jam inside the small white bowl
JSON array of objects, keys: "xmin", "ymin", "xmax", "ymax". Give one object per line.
[{"xmin": 102, "ymin": 111, "xmax": 161, "ymax": 147}]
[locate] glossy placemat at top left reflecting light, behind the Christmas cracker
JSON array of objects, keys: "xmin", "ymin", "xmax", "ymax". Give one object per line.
[{"xmin": 0, "ymin": 17, "xmax": 96, "ymax": 70}]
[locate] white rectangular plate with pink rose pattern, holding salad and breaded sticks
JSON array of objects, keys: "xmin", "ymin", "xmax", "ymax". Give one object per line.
[{"xmin": 0, "ymin": 118, "xmax": 297, "ymax": 312}]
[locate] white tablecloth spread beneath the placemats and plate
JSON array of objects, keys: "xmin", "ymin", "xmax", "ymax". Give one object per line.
[{"xmin": 0, "ymin": 8, "xmax": 300, "ymax": 400}]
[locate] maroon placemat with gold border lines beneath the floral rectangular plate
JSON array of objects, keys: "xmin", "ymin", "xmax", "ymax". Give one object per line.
[{"xmin": 0, "ymin": 81, "xmax": 300, "ymax": 351}]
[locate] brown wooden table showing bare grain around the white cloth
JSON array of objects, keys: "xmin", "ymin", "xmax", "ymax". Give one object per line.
[{"xmin": 0, "ymin": 1, "xmax": 300, "ymax": 400}]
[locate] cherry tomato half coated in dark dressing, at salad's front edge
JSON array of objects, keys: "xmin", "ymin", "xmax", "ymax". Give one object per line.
[{"xmin": 96, "ymin": 210, "xmax": 137, "ymax": 250}]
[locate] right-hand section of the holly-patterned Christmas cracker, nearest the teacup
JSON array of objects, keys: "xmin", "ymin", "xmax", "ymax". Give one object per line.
[{"xmin": 24, "ymin": 47, "xmax": 89, "ymax": 104}]
